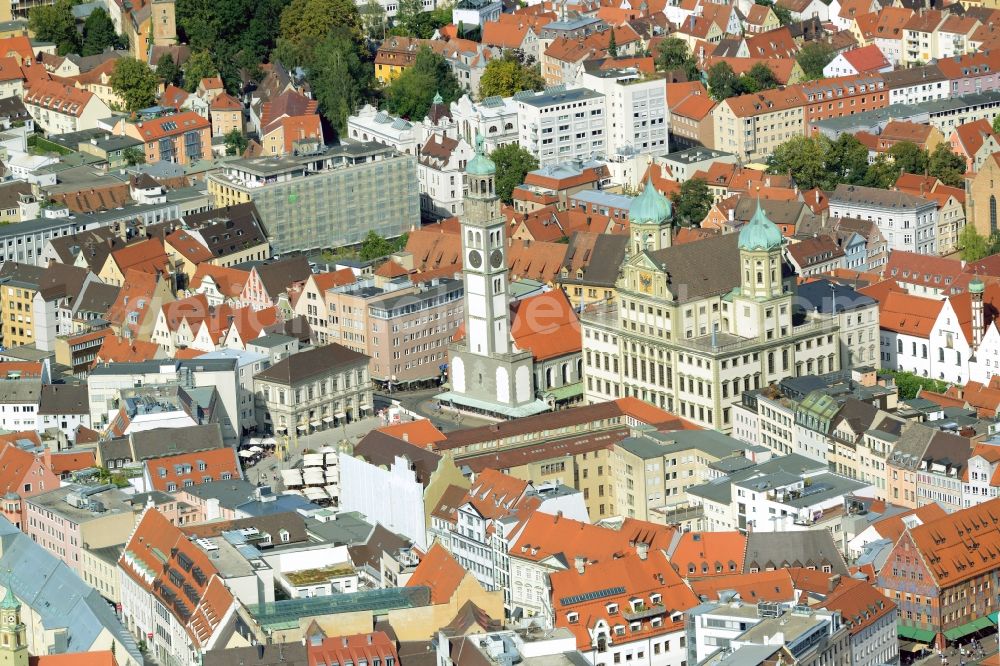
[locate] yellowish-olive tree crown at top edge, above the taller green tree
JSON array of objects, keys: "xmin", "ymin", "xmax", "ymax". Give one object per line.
[{"xmin": 279, "ymin": 0, "xmax": 361, "ymax": 64}]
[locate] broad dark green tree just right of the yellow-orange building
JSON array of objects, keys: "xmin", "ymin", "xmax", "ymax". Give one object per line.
[{"xmin": 385, "ymin": 46, "xmax": 462, "ymax": 120}]
